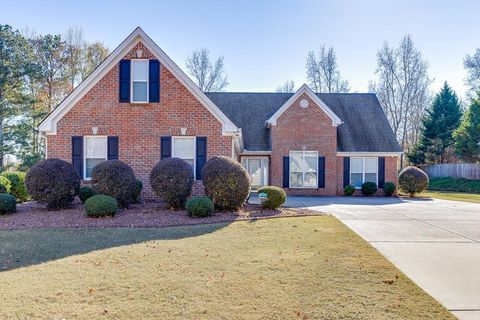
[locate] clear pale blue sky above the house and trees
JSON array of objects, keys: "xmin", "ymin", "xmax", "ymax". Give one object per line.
[{"xmin": 0, "ymin": 0, "xmax": 480, "ymax": 95}]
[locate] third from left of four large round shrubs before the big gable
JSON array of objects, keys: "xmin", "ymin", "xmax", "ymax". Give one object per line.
[{"xmin": 150, "ymin": 158, "xmax": 193, "ymax": 210}]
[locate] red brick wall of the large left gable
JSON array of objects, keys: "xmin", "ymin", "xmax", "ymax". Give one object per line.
[{"xmin": 47, "ymin": 43, "xmax": 232, "ymax": 197}]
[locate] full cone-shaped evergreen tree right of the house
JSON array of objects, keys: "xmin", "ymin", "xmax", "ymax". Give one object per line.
[{"xmin": 408, "ymin": 82, "xmax": 462, "ymax": 164}]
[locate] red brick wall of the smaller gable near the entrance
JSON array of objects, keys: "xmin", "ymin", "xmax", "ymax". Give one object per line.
[{"xmin": 270, "ymin": 94, "xmax": 337, "ymax": 195}]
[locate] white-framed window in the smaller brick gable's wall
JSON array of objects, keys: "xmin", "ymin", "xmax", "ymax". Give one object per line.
[{"xmin": 289, "ymin": 151, "xmax": 318, "ymax": 188}]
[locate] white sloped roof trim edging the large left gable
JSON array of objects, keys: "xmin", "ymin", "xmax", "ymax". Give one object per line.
[{"xmin": 38, "ymin": 27, "xmax": 239, "ymax": 135}]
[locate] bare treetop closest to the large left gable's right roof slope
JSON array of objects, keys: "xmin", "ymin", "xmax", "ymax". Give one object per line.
[{"xmin": 186, "ymin": 49, "xmax": 228, "ymax": 92}]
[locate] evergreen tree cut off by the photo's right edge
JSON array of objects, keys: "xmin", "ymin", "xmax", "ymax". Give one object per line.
[{"xmin": 454, "ymin": 93, "xmax": 480, "ymax": 163}]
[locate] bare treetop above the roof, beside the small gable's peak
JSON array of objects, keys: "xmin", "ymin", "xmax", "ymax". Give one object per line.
[{"xmin": 305, "ymin": 44, "xmax": 350, "ymax": 92}]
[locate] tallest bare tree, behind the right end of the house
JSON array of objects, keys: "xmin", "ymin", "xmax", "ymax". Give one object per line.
[{"xmin": 369, "ymin": 35, "xmax": 432, "ymax": 165}]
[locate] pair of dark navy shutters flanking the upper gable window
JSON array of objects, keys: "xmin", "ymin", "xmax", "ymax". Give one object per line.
[{"xmin": 119, "ymin": 60, "xmax": 160, "ymax": 102}]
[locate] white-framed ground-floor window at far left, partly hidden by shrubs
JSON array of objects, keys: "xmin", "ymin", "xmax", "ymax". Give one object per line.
[{"xmin": 83, "ymin": 136, "xmax": 107, "ymax": 180}]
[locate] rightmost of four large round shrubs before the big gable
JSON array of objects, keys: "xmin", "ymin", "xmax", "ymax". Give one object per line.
[{"xmin": 202, "ymin": 157, "xmax": 250, "ymax": 211}]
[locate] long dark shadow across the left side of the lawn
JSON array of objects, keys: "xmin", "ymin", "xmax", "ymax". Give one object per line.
[{"xmin": 0, "ymin": 222, "xmax": 231, "ymax": 271}]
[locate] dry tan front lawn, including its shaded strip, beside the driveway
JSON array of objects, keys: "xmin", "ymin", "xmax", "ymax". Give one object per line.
[{"xmin": 0, "ymin": 216, "xmax": 454, "ymax": 319}]
